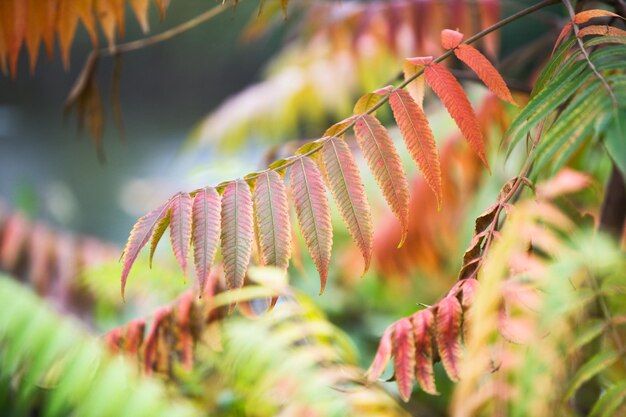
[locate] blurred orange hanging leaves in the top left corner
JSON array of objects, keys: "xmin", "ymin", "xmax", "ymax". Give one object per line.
[{"xmin": 0, "ymin": 0, "xmax": 169, "ymax": 77}]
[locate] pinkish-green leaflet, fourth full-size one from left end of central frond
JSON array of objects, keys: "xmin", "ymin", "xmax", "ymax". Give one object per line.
[{"xmin": 217, "ymin": 180, "xmax": 254, "ymax": 289}]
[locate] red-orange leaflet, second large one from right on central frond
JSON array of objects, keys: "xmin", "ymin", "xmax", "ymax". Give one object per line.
[{"xmin": 425, "ymin": 63, "xmax": 489, "ymax": 169}]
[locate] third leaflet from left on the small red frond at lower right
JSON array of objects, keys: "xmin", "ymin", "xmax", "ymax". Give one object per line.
[{"xmin": 411, "ymin": 309, "xmax": 437, "ymax": 395}]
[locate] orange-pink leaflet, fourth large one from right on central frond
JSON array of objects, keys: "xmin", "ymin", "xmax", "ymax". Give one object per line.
[{"xmin": 354, "ymin": 114, "xmax": 409, "ymax": 246}]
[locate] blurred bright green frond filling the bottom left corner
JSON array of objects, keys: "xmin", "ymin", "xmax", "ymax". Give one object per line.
[{"xmin": 0, "ymin": 276, "xmax": 200, "ymax": 417}]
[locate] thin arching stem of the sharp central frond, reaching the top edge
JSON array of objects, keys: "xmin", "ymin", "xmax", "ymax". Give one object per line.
[{"xmin": 190, "ymin": 0, "xmax": 559, "ymax": 195}]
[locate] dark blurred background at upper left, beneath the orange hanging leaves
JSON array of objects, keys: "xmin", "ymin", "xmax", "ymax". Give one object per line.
[{"xmin": 0, "ymin": 0, "xmax": 282, "ymax": 240}]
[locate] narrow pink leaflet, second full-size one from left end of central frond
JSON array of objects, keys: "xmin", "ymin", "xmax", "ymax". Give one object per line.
[{"xmin": 170, "ymin": 193, "xmax": 192, "ymax": 274}]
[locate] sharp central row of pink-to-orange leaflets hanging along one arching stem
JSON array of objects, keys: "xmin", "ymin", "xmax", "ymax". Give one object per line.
[{"xmin": 122, "ymin": 31, "xmax": 512, "ymax": 295}]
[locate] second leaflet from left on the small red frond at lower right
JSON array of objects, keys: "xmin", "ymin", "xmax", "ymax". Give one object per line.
[{"xmin": 393, "ymin": 318, "xmax": 415, "ymax": 402}]
